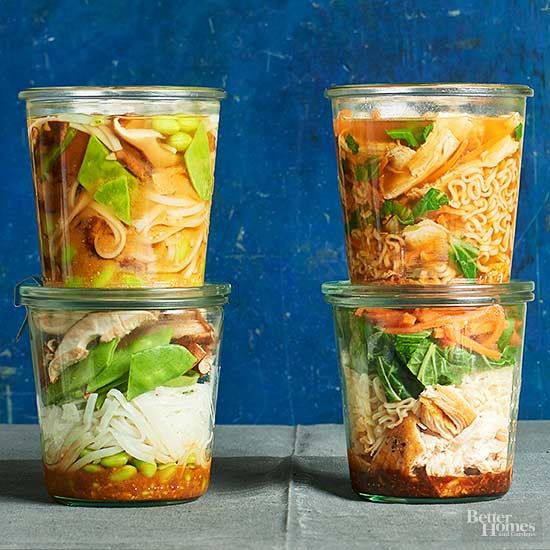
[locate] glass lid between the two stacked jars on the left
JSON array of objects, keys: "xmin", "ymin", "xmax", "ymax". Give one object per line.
[{"xmin": 15, "ymin": 283, "xmax": 231, "ymax": 311}]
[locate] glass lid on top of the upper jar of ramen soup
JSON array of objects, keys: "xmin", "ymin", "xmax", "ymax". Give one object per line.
[{"xmin": 325, "ymin": 82, "xmax": 533, "ymax": 99}]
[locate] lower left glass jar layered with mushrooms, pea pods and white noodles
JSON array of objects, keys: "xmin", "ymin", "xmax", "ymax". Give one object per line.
[{"xmin": 19, "ymin": 284, "xmax": 230, "ymax": 506}]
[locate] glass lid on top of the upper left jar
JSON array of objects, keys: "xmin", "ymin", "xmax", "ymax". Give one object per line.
[{"xmin": 18, "ymin": 86, "xmax": 227, "ymax": 102}]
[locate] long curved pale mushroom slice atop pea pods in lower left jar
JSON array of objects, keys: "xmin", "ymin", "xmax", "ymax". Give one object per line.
[{"xmin": 48, "ymin": 311, "xmax": 158, "ymax": 382}]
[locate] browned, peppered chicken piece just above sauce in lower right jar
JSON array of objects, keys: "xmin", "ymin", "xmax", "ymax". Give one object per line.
[{"xmin": 371, "ymin": 413, "xmax": 425, "ymax": 475}]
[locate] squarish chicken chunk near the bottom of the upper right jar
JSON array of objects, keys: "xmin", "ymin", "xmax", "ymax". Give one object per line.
[{"xmin": 403, "ymin": 220, "xmax": 449, "ymax": 268}]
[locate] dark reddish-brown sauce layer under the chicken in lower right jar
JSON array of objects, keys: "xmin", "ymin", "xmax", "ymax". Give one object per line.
[{"xmin": 349, "ymin": 453, "xmax": 512, "ymax": 498}]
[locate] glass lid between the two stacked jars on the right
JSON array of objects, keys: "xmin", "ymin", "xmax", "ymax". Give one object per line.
[{"xmin": 321, "ymin": 281, "xmax": 535, "ymax": 308}]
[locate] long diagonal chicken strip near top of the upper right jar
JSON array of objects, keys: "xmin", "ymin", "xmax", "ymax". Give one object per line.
[{"xmin": 383, "ymin": 117, "xmax": 473, "ymax": 199}]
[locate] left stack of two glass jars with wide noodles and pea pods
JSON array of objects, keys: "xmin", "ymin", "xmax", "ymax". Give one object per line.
[{"xmin": 19, "ymin": 87, "xmax": 230, "ymax": 505}]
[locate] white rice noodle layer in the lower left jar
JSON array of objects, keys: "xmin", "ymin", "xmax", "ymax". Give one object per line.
[{"xmin": 40, "ymin": 382, "xmax": 214, "ymax": 471}]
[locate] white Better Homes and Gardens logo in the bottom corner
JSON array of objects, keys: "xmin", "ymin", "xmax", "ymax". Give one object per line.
[{"xmin": 463, "ymin": 509, "xmax": 542, "ymax": 540}]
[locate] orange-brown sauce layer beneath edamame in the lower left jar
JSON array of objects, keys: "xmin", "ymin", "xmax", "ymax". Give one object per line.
[{"xmin": 44, "ymin": 462, "xmax": 211, "ymax": 502}]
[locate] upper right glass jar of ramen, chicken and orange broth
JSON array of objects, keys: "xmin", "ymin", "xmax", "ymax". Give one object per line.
[{"xmin": 326, "ymin": 84, "xmax": 533, "ymax": 284}]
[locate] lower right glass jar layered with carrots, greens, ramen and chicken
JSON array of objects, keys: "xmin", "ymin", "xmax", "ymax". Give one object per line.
[{"xmin": 323, "ymin": 281, "xmax": 534, "ymax": 502}]
